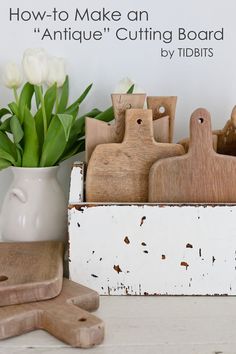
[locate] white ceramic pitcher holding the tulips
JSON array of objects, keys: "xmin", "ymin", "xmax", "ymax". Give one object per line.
[{"xmin": 0, "ymin": 166, "xmax": 67, "ymax": 242}]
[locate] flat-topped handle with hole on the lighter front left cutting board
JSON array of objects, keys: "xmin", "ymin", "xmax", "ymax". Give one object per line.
[{"xmin": 123, "ymin": 109, "xmax": 154, "ymax": 145}]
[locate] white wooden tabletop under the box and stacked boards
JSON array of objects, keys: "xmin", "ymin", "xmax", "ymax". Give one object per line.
[{"xmin": 0, "ymin": 296, "xmax": 236, "ymax": 354}]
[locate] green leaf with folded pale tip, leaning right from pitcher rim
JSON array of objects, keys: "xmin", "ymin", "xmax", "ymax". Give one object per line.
[{"xmin": 40, "ymin": 115, "xmax": 72, "ymax": 167}]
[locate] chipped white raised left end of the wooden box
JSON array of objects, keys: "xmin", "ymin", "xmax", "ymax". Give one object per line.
[{"xmin": 69, "ymin": 162, "xmax": 85, "ymax": 204}]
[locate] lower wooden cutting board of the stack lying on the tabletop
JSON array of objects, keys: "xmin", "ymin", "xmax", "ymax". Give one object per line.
[{"xmin": 0, "ymin": 279, "xmax": 104, "ymax": 348}]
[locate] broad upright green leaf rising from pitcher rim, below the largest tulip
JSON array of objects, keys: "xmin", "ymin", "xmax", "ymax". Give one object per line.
[{"xmin": 22, "ymin": 107, "xmax": 39, "ymax": 167}]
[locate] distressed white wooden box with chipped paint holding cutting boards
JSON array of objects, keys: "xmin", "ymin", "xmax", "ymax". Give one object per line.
[{"xmin": 69, "ymin": 163, "xmax": 236, "ymax": 295}]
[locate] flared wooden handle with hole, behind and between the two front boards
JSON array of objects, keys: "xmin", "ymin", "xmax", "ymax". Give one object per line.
[{"xmin": 147, "ymin": 96, "xmax": 177, "ymax": 143}]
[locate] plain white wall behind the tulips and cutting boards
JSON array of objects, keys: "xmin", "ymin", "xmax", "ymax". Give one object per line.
[{"xmin": 0, "ymin": 0, "xmax": 236, "ymax": 205}]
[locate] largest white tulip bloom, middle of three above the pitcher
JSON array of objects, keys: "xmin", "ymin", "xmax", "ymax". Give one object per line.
[{"xmin": 23, "ymin": 48, "xmax": 48, "ymax": 86}]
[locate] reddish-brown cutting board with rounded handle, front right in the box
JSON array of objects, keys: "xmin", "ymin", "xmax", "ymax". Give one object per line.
[{"xmin": 149, "ymin": 108, "xmax": 236, "ymax": 203}]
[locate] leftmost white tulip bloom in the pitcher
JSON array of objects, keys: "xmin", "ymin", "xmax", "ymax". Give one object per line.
[{"xmin": 3, "ymin": 62, "xmax": 23, "ymax": 89}]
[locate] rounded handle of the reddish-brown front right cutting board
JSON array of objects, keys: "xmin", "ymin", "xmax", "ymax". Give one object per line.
[{"xmin": 189, "ymin": 108, "xmax": 214, "ymax": 155}]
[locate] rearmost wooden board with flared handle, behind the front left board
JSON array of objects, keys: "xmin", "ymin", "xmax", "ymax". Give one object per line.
[{"xmin": 85, "ymin": 94, "xmax": 146, "ymax": 162}]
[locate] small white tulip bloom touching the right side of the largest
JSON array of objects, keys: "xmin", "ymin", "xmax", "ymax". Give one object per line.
[{"xmin": 47, "ymin": 57, "xmax": 66, "ymax": 87}]
